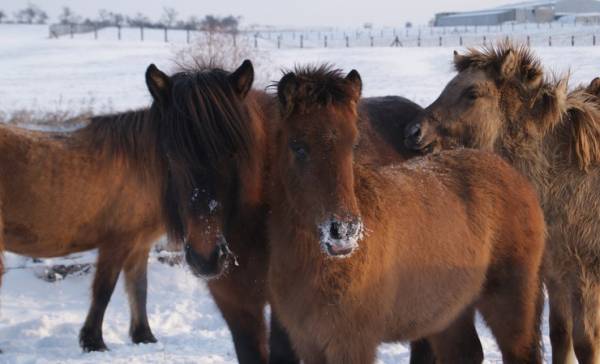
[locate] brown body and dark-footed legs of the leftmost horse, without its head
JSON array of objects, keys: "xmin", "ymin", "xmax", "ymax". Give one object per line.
[{"xmin": 0, "ymin": 112, "xmax": 164, "ymax": 350}]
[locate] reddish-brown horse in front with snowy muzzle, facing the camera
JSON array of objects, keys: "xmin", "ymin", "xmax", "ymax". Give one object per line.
[{"xmin": 268, "ymin": 68, "xmax": 544, "ymax": 364}]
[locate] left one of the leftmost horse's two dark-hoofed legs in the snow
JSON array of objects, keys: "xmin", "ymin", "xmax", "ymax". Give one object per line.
[{"xmin": 79, "ymin": 247, "xmax": 124, "ymax": 352}]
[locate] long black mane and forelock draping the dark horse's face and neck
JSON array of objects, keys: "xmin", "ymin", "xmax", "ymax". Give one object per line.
[{"xmin": 158, "ymin": 68, "xmax": 254, "ymax": 241}]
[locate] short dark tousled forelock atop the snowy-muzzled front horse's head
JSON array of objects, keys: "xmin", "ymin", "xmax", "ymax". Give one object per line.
[{"xmin": 271, "ymin": 63, "xmax": 356, "ymax": 112}]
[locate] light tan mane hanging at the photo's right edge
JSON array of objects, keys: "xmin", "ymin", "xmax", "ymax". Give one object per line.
[{"xmin": 564, "ymin": 88, "xmax": 600, "ymax": 171}]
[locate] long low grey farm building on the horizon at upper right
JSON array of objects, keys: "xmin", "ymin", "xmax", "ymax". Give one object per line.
[{"xmin": 434, "ymin": 0, "xmax": 600, "ymax": 26}]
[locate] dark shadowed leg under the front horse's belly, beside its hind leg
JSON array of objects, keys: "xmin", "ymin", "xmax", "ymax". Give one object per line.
[{"xmin": 428, "ymin": 307, "xmax": 483, "ymax": 364}]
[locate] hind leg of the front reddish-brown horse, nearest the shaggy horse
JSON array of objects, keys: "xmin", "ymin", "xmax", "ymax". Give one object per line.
[{"xmin": 477, "ymin": 262, "xmax": 543, "ymax": 364}]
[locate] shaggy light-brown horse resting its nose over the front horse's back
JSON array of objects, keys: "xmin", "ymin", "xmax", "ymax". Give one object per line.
[{"xmin": 406, "ymin": 43, "xmax": 600, "ymax": 363}]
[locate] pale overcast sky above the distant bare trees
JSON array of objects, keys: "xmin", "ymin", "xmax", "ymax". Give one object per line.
[{"xmin": 0, "ymin": 0, "xmax": 514, "ymax": 26}]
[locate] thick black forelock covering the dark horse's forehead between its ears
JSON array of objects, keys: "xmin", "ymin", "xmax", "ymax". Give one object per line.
[{"xmin": 161, "ymin": 68, "xmax": 252, "ymax": 167}]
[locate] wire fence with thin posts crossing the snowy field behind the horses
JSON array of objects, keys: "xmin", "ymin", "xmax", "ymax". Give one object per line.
[{"xmin": 50, "ymin": 22, "xmax": 600, "ymax": 49}]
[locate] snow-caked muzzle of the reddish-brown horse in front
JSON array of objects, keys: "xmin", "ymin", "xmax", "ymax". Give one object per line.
[{"xmin": 318, "ymin": 216, "xmax": 364, "ymax": 258}]
